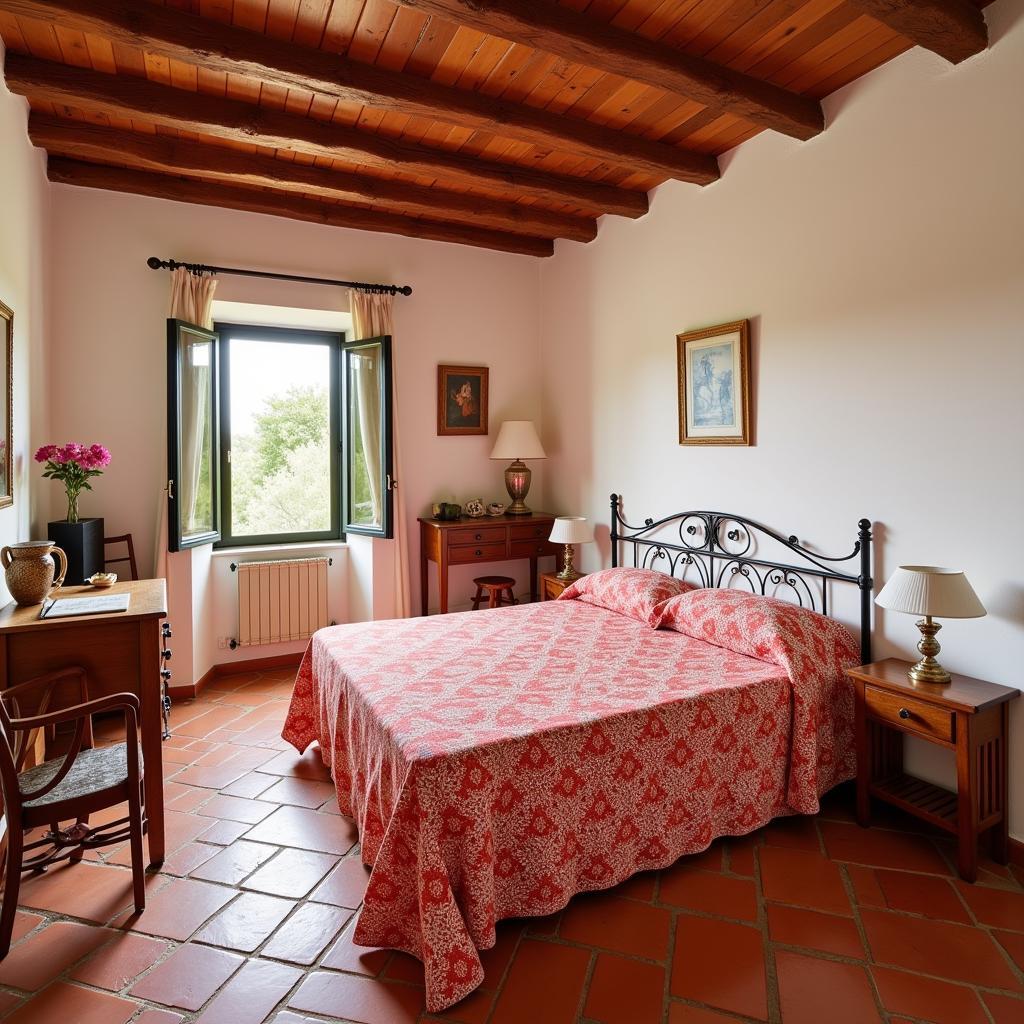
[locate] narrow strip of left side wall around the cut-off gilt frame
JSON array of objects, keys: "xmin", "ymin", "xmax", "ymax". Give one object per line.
[{"xmin": 0, "ymin": 42, "xmax": 49, "ymax": 604}]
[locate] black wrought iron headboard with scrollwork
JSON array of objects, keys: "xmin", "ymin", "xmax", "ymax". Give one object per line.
[{"xmin": 611, "ymin": 495, "xmax": 873, "ymax": 665}]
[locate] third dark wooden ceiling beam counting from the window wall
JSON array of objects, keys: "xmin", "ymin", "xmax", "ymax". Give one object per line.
[{"xmin": 4, "ymin": 52, "xmax": 647, "ymax": 217}]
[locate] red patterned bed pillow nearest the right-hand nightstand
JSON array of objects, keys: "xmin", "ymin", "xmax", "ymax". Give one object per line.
[{"xmin": 652, "ymin": 588, "xmax": 860, "ymax": 671}]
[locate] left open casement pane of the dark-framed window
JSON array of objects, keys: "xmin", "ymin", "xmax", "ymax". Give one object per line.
[{"xmin": 167, "ymin": 319, "xmax": 220, "ymax": 551}]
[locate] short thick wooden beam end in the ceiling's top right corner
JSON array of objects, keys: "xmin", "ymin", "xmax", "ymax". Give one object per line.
[{"xmin": 835, "ymin": 0, "xmax": 988, "ymax": 63}]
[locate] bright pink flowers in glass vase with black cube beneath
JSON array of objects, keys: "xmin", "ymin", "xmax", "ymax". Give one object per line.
[{"xmin": 35, "ymin": 441, "xmax": 111, "ymax": 586}]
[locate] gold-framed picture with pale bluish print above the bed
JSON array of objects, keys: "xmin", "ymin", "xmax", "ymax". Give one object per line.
[{"xmin": 676, "ymin": 321, "xmax": 752, "ymax": 444}]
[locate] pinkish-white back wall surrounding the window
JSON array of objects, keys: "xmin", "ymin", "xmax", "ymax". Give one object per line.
[{"xmin": 43, "ymin": 185, "xmax": 543, "ymax": 671}]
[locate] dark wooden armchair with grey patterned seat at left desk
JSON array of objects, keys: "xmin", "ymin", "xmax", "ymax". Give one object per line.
[{"xmin": 0, "ymin": 668, "xmax": 146, "ymax": 959}]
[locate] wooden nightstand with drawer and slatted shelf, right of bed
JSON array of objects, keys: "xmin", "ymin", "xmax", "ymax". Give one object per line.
[{"xmin": 847, "ymin": 657, "xmax": 1020, "ymax": 882}]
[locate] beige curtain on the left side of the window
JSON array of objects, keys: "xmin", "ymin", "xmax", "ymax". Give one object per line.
[{"xmin": 156, "ymin": 267, "xmax": 217, "ymax": 577}]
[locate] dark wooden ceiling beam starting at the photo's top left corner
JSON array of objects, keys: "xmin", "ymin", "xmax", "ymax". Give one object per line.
[{"xmin": 0, "ymin": 0, "xmax": 719, "ymax": 184}]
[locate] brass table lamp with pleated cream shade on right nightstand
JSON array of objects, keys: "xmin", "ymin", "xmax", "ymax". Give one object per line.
[{"xmin": 874, "ymin": 565, "xmax": 986, "ymax": 683}]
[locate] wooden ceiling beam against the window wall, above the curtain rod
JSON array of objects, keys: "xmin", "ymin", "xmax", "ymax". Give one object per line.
[{"xmin": 47, "ymin": 157, "xmax": 554, "ymax": 256}]
